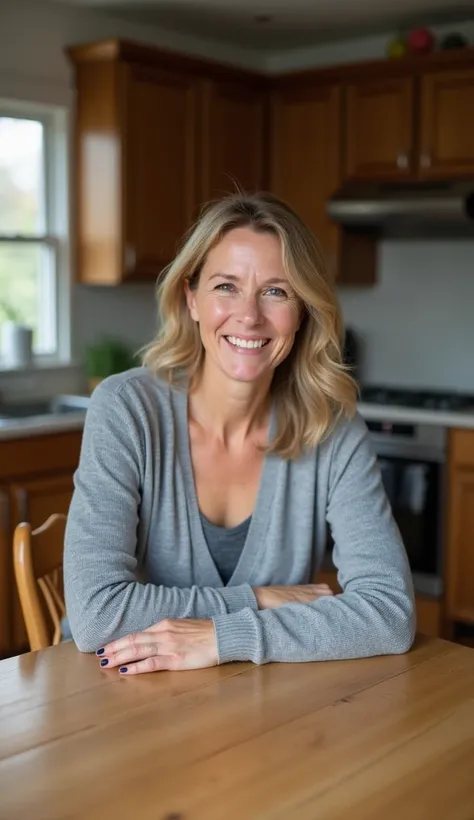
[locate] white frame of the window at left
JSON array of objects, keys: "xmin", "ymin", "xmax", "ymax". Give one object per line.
[{"xmin": 0, "ymin": 97, "xmax": 71, "ymax": 370}]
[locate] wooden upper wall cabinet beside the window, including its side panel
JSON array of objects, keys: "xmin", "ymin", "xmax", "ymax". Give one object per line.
[{"xmin": 67, "ymin": 40, "xmax": 264, "ymax": 285}]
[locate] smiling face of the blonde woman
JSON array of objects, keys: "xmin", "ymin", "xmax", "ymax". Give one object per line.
[{"xmin": 186, "ymin": 228, "xmax": 303, "ymax": 382}]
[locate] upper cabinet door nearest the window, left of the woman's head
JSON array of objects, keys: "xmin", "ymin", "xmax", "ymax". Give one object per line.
[{"xmin": 122, "ymin": 65, "xmax": 197, "ymax": 280}]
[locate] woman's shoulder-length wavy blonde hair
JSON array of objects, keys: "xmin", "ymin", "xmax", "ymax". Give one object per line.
[{"xmin": 143, "ymin": 193, "xmax": 357, "ymax": 459}]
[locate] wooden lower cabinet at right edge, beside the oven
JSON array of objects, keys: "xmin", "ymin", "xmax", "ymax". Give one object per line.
[{"xmin": 446, "ymin": 430, "xmax": 474, "ymax": 624}]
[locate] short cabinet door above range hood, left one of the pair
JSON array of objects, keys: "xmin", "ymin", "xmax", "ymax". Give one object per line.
[{"xmin": 345, "ymin": 77, "xmax": 414, "ymax": 179}]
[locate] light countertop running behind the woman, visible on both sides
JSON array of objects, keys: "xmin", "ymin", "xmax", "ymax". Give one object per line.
[{"xmin": 0, "ymin": 402, "xmax": 474, "ymax": 441}]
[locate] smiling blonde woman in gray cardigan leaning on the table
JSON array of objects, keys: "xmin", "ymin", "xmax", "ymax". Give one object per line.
[{"xmin": 64, "ymin": 195, "xmax": 415, "ymax": 675}]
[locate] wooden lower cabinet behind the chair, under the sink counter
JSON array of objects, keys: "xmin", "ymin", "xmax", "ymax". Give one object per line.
[{"xmin": 0, "ymin": 431, "xmax": 82, "ymax": 658}]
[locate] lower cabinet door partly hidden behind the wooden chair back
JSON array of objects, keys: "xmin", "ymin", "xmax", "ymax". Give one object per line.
[{"xmin": 11, "ymin": 472, "xmax": 74, "ymax": 653}]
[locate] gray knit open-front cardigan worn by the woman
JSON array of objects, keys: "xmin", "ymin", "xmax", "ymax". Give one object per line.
[{"xmin": 64, "ymin": 368, "xmax": 415, "ymax": 663}]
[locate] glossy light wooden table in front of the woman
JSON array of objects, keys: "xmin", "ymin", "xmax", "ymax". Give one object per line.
[{"xmin": 0, "ymin": 638, "xmax": 474, "ymax": 820}]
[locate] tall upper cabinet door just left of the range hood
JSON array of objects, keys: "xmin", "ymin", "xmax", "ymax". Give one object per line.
[{"xmin": 271, "ymin": 86, "xmax": 341, "ymax": 273}]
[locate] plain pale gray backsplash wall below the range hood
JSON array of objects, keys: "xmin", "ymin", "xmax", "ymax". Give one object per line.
[{"xmin": 339, "ymin": 240, "xmax": 474, "ymax": 393}]
